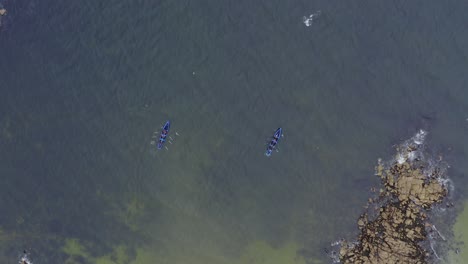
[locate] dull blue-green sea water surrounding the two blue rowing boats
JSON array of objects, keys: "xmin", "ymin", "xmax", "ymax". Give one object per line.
[{"xmin": 0, "ymin": 1, "xmax": 468, "ymax": 263}]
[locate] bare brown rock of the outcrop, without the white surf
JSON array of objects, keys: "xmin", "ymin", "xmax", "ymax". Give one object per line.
[{"xmin": 339, "ymin": 141, "xmax": 447, "ymax": 264}]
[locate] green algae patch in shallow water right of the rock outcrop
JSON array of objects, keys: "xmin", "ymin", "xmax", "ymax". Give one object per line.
[{"xmin": 448, "ymin": 201, "xmax": 468, "ymax": 264}]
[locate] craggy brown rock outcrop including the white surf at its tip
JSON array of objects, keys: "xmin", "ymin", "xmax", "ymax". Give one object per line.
[{"xmin": 333, "ymin": 131, "xmax": 449, "ymax": 264}]
